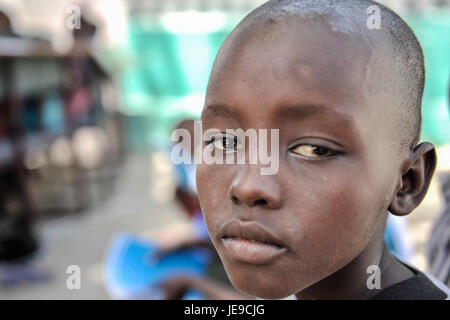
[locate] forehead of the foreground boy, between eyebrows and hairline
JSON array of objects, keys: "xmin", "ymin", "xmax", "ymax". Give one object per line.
[{"xmin": 206, "ymin": 19, "xmax": 386, "ymax": 123}]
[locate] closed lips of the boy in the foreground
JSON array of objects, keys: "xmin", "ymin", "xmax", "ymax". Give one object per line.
[{"xmin": 219, "ymin": 219, "xmax": 287, "ymax": 264}]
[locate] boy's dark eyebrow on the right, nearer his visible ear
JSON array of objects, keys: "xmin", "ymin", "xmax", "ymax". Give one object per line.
[{"xmin": 277, "ymin": 104, "xmax": 353, "ymax": 126}]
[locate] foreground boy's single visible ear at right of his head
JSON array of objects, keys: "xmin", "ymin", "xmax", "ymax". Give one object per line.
[{"xmin": 388, "ymin": 142, "xmax": 436, "ymax": 216}]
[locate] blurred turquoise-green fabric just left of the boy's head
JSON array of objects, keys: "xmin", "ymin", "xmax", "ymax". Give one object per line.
[{"xmin": 121, "ymin": 19, "xmax": 229, "ymax": 147}]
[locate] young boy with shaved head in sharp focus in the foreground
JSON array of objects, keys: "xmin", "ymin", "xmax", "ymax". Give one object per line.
[{"xmin": 197, "ymin": 0, "xmax": 448, "ymax": 299}]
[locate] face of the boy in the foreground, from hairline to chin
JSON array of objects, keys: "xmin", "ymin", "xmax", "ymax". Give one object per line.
[{"xmin": 197, "ymin": 20, "xmax": 401, "ymax": 298}]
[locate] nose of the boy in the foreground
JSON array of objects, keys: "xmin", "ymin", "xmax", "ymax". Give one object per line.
[{"xmin": 229, "ymin": 165, "xmax": 282, "ymax": 209}]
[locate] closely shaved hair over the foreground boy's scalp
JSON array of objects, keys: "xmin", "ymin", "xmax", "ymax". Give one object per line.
[{"xmin": 216, "ymin": 0, "xmax": 425, "ymax": 150}]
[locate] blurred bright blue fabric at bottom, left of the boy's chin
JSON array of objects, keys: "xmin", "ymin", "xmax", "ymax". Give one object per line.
[{"xmin": 106, "ymin": 234, "xmax": 209, "ymax": 299}]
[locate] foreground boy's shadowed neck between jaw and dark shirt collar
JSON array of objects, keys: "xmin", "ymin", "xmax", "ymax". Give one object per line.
[{"xmin": 296, "ymin": 236, "xmax": 414, "ymax": 300}]
